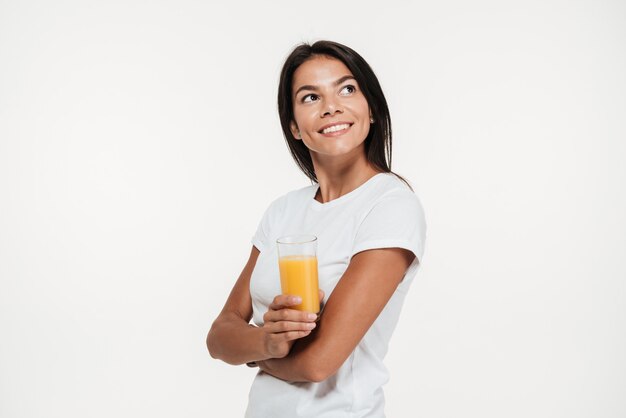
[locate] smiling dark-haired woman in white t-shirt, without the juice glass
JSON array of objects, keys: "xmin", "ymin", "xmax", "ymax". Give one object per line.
[{"xmin": 207, "ymin": 41, "xmax": 426, "ymax": 418}]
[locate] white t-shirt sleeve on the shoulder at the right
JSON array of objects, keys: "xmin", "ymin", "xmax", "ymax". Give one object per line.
[{"xmin": 351, "ymin": 188, "xmax": 426, "ymax": 263}]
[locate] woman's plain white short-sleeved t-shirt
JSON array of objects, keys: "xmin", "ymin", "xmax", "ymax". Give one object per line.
[{"xmin": 246, "ymin": 173, "xmax": 426, "ymax": 418}]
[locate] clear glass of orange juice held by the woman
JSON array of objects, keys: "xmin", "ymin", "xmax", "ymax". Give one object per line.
[{"xmin": 276, "ymin": 235, "xmax": 320, "ymax": 313}]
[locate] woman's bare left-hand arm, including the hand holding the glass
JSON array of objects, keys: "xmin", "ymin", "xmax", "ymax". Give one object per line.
[{"xmin": 206, "ymin": 246, "xmax": 314, "ymax": 364}]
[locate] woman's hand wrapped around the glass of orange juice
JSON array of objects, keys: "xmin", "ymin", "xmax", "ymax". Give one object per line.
[{"xmin": 261, "ymin": 290, "xmax": 324, "ymax": 358}]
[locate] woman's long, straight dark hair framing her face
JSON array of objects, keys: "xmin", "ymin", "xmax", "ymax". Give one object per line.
[{"xmin": 278, "ymin": 41, "xmax": 408, "ymax": 184}]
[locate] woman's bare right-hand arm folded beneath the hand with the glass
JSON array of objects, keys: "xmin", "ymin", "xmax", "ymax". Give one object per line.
[{"xmin": 258, "ymin": 248, "xmax": 415, "ymax": 382}]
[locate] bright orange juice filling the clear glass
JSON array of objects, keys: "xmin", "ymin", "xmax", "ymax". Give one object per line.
[{"xmin": 278, "ymin": 255, "xmax": 320, "ymax": 313}]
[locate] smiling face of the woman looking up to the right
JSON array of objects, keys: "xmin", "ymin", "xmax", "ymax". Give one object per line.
[{"xmin": 291, "ymin": 56, "xmax": 370, "ymax": 158}]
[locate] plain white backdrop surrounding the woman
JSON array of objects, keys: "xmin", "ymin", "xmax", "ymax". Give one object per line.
[{"xmin": 0, "ymin": 0, "xmax": 626, "ymax": 418}]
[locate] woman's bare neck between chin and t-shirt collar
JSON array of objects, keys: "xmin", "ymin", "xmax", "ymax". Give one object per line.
[{"xmin": 311, "ymin": 151, "xmax": 382, "ymax": 203}]
